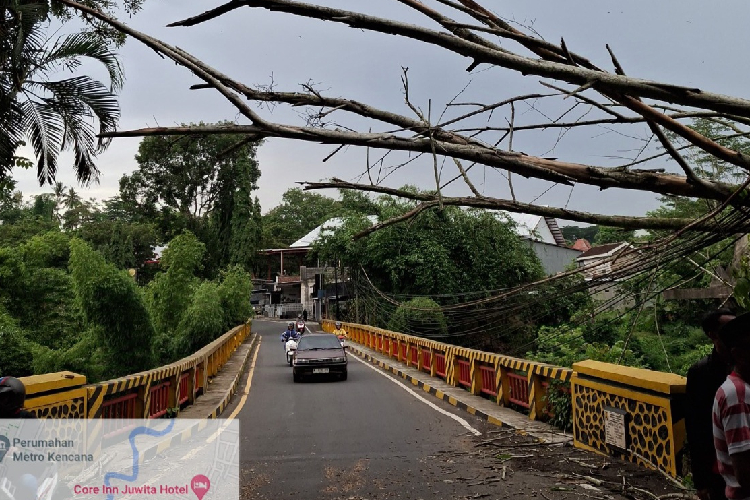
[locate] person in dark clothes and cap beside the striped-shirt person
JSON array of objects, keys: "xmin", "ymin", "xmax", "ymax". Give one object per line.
[{"xmin": 685, "ymin": 309, "xmax": 735, "ymax": 500}]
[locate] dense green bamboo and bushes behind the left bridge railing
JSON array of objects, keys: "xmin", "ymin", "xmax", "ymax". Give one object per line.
[{"xmin": 0, "ymin": 131, "xmax": 260, "ymax": 381}]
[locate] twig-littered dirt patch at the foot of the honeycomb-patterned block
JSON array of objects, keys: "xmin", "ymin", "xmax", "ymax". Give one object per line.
[{"xmin": 428, "ymin": 427, "xmax": 697, "ymax": 500}]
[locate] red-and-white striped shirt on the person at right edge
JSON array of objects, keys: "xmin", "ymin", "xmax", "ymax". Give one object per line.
[{"xmin": 713, "ymin": 372, "xmax": 750, "ymax": 500}]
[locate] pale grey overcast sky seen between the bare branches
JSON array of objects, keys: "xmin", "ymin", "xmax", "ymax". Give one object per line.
[{"xmin": 14, "ymin": 0, "xmax": 750, "ymax": 223}]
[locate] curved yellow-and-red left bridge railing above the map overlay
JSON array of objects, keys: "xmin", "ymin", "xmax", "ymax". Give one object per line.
[{"xmin": 16, "ymin": 322, "xmax": 250, "ymax": 426}]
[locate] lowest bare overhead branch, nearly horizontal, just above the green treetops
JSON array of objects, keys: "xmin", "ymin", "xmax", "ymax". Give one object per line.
[{"xmin": 303, "ymin": 178, "xmax": 750, "ymax": 233}]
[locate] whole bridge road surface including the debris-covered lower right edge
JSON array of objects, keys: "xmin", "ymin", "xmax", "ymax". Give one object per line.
[{"xmin": 239, "ymin": 320, "xmax": 671, "ymax": 500}]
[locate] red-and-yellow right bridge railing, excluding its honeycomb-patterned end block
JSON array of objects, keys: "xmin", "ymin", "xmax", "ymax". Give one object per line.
[{"xmin": 321, "ymin": 320, "xmax": 573, "ymax": 420}]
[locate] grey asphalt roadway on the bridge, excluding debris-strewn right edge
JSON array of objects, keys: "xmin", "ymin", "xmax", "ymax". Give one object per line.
[{"xmin": 237, "ymin": 320, "xmax": 497, "ymax": 499}]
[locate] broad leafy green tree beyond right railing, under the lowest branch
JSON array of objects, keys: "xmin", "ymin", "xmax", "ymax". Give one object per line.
[{"xmin": 316, "ymin": 192, "xmax": 544, "ymax": 295}]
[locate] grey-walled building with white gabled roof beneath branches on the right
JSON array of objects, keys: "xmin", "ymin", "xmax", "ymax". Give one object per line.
[{"xmin": 500, "ymin": 212, "xmax": 581, "ymax": 275}]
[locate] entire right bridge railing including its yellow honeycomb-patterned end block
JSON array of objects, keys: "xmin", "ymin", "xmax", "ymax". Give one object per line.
[{"xmin": 321, "ymin": 320, "xmax": 689, "ymax": 476}]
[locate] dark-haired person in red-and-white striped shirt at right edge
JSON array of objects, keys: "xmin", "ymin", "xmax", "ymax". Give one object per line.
[{"xmin": 713, "ymin": 313, "xmax": 750, "ymax": 500}]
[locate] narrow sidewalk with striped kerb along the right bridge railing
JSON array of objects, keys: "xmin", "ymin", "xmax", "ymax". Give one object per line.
[{"xmin": 348, "ymin": 343, "xmax": 573, "ymax": 443}]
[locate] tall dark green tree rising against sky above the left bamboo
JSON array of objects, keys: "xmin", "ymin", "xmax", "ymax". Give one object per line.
[{"xmin": 125, "ymin": 124, "xmax": 261, "ymax": 277}]
